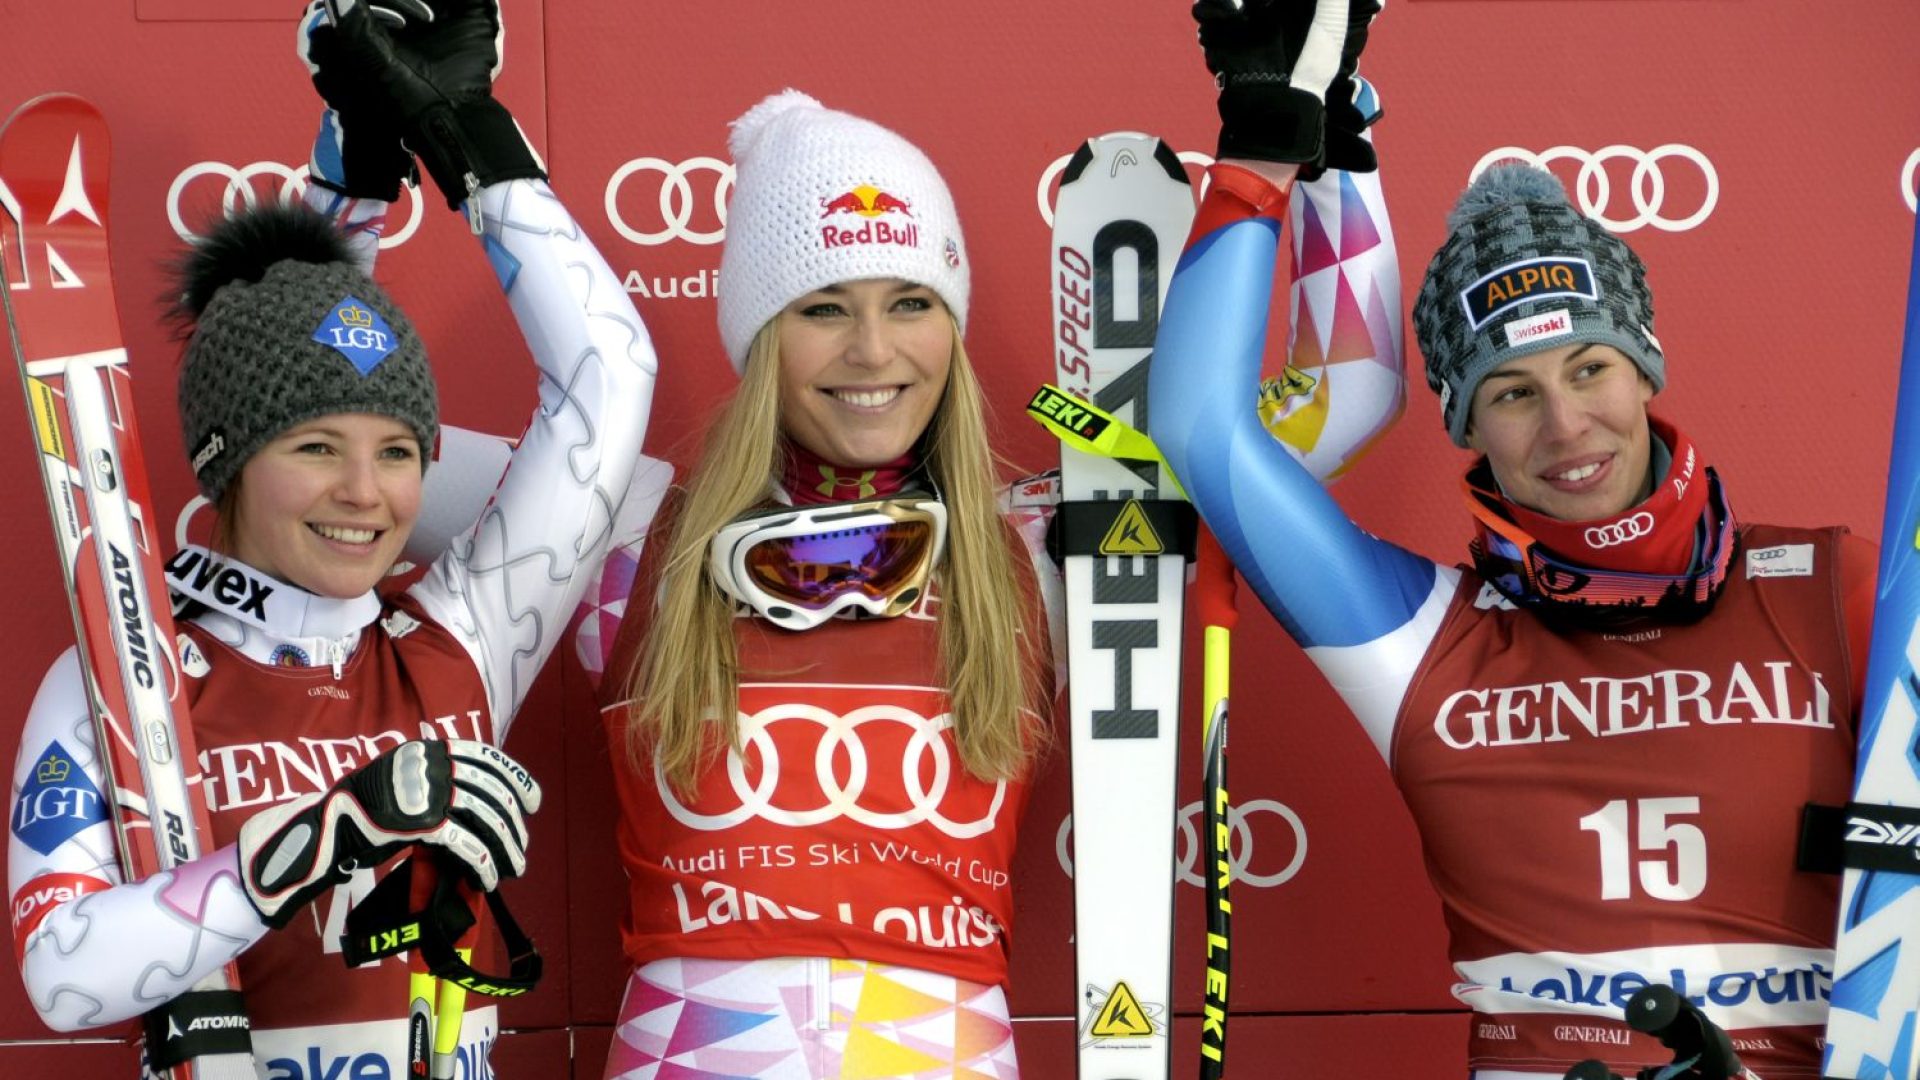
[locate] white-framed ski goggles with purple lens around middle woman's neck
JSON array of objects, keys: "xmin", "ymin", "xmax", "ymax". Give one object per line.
[{"xmin": 707, "ymin": 496, "xmax": 947, "ymax": 630}]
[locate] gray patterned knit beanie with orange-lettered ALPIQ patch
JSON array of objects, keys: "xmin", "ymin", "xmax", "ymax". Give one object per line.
[{"xmin": 1413, "ymin": 163, "xmax": 1667, "ymax": 446}]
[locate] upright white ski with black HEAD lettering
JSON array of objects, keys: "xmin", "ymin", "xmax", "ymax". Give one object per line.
[{"xmin": 1048, "ymin": 133, "xmax": 1194, "ymax": 1080}]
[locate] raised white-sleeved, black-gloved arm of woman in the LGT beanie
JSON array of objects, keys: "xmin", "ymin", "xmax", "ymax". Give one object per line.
[{"xmin": 307, "ymin": 0, "xmax": 655, "ymax": 734}]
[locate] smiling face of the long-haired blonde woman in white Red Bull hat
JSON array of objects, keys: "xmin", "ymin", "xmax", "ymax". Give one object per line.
[{"xmin": 776, "ymin": 279, "xmax": 954, "ymax": 467}]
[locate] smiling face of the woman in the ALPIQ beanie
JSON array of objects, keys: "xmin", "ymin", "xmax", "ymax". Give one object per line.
[{"xmin": 1467, "ymin": 344, "xmax": 1653, "ymax": 521}]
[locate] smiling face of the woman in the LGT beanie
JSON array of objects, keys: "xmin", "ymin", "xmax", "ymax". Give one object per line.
[{"xmin": 228, "ymin": 413, "xmax": 420, "ymax": 600}]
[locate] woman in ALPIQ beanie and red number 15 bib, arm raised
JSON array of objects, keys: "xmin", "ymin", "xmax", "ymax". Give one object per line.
[{"xmin": 1150, "ymin": 4, "xmax": 1874, "ymax": 1080}]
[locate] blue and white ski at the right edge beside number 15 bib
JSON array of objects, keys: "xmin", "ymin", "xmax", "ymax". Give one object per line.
[{"xmin": 1822, "ymin": 195, "xmax": 1920, "ymax": 1080}]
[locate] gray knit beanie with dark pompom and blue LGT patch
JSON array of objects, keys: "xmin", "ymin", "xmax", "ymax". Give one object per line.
[{"xmin": 179, "ymin": 206, "xmax": 440, "ymax": 502}]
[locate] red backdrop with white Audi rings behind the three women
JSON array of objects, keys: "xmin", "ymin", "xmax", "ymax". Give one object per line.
[{"xmin": 0, "ymin": 0, "xmax": 1920, "ymax": 1080}]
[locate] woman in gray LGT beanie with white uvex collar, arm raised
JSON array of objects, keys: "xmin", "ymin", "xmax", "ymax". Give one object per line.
[{"xmin": 8, "ymin": 0, "xmax": 655, "ymax": 1076}]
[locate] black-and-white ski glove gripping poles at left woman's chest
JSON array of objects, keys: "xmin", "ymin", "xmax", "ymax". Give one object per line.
[{"xmin": 240, "ymin": 740, "xmax": 540, "ymax": 926}]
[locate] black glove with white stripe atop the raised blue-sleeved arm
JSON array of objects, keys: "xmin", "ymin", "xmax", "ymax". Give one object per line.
[{"xmin": 1192, "ymin": 0, "xmax": 1380, "ymax": 175}]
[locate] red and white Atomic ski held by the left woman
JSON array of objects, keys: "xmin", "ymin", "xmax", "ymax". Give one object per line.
[{"xmin": 0, "ymin": 94, "xmax": 253, "ymax": 1080}]
